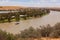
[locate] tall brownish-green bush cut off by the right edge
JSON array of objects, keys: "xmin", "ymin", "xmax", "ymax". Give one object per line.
[{"xmin": 50, "ymin": 23, "xmax": 60, "ymax": 38}]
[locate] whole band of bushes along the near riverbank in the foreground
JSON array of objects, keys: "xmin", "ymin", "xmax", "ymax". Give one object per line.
[{"xmin": 0, "ymin": 23, "xmax": 60, "ymax": 40}]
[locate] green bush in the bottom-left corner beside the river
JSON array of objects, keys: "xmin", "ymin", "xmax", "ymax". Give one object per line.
[{"xmin": 0, "ymin": 30, "xmax": 15, "ymax": 40}]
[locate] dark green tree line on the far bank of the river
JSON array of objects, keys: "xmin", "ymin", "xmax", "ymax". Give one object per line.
[{"xmin": 0, "ymin": 8, "xmax": 50, "ymax": 22}]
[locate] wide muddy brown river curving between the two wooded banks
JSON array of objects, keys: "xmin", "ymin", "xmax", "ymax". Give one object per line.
[{"xmin": 0, "ymin": 11, "xmax": 60, "ymax": 34}]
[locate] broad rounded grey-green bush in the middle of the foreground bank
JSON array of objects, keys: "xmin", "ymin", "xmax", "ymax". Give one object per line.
[{"xmin": 20, "ymin": 27, "xmax": 40, "ymax": 38}]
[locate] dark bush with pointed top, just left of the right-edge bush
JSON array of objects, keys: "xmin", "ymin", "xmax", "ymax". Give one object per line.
[{"xmin": 40, "ymin": 24, "xmax": 52, "ymax": 37}]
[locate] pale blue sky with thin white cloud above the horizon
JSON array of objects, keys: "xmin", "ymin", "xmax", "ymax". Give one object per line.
[{"xmin": 0, "ymin": 0, "xmax": 60, "ymax": 7}]
